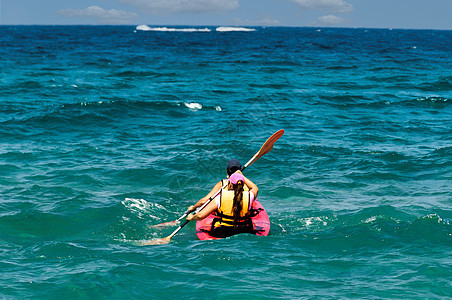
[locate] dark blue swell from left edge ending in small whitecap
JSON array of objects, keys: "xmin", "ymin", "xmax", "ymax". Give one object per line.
[{"xmin": 0, "ymin": 99, "xmax": 223, "ymax": 139}]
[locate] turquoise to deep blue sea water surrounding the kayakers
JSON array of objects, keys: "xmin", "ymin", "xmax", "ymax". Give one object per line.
[{"xmin": 0, "ymin": 26, "xmax": 452, "ymax": 299}]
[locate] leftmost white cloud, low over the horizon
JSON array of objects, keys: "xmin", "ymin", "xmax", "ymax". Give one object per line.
[{"xmin": 57, "ymin": 6, "xmax": 138, "ymax": 24}]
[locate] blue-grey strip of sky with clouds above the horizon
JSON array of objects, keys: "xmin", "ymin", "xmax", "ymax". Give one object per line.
[{"xmin": 0, "ymin": 0, "xmax": 452, "ymax": 30}]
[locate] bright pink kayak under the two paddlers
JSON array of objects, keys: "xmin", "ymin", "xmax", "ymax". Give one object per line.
[{"xmin": 196, "ymin": 200, "xmax": 270, "ymax": 240}]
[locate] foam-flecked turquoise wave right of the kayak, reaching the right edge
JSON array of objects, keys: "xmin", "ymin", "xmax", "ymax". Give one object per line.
[{"xmin": 272, "ymin": 205, "xmax": 452, "ymax": 246}]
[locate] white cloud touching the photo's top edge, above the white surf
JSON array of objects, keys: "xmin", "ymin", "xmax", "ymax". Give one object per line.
[{"xmin": 120, "ymin": 0, "xmax": 239, "ymax": 14}]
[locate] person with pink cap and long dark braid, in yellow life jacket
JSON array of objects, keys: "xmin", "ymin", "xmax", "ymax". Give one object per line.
[{"xmin": 187, "ymin": 170, "xmax": 259, "ymax": 238}]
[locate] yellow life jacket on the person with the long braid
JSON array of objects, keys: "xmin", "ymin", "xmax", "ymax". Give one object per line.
[{"xmin": 214, "ymin": 185, "xmax": 250, "ymax": 227}]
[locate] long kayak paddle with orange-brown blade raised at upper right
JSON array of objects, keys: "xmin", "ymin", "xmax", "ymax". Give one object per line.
[{"xmin": 144, "ymin": 129, "xmax": 284, "ymax": 245}]
